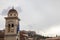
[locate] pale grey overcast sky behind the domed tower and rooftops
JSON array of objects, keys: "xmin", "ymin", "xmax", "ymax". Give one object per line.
[{"xmin": 0, "ymin": 0, "xmax": 60, "ymax": 36}]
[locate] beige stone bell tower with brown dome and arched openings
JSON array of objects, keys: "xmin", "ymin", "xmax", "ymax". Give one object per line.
[{"xmin": 4, "ymin": 8, "xmax": 20, "ymax": 40}]
